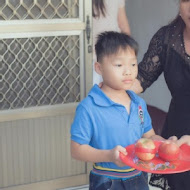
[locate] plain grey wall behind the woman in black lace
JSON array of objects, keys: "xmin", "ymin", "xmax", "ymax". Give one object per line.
[{"xmin": 126, "ymin": 0, "xmax": 178, "ymax": 111}]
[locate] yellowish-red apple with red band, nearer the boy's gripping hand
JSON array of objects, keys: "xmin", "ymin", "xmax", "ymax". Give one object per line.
[{"xmin": 135, "ymin": 138, "xmax": 156, "ymax": 161}]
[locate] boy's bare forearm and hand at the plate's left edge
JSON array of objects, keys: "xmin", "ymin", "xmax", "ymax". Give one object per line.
[{"xmin": 71, "ymin": 141, "xmax": 127, "ymax": 166}]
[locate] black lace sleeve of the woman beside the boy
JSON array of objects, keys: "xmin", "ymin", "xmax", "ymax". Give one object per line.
[{"xmin": 137, "ymin": 27, "xmax": 166, "ymax": 90}]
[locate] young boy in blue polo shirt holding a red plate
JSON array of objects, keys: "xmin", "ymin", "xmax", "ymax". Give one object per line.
[{"xmin": 71, "ymin": 32, "xmax": 161, "ymax": 190}]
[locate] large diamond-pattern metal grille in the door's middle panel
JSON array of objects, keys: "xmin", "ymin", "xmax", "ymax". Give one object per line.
[{"xmin": 0, "ymin": 36, "xmax": 80, "ymax": 110}]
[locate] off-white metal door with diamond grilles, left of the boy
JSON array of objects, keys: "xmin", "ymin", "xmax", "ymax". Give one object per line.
[{"xmin": 0, "ymin": 0, "xmax": 92, "ymax": 190}]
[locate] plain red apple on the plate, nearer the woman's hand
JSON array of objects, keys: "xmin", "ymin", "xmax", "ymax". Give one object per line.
[{"xmin": 158, "ymin": 141, "xmax": 180, "ymax": 161}]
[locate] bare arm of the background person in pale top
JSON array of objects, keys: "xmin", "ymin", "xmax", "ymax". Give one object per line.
[{"xmin": 118, "ymin": 6, "xmax": 131, "ymax": 35}]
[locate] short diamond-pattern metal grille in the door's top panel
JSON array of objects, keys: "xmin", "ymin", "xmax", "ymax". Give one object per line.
[{"xmin": 0, "ymin": 0, "xmax": 80, "ymax": 20}]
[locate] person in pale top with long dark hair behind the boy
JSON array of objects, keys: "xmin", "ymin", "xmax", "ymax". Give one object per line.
[{"xmin": 92, "ymin": 0, "xmax": 130, "ymax": 84}]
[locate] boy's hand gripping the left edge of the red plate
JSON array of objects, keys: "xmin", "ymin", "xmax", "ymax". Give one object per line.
[{"xmin": 110, "ymin": 145, "xmax": 127, "ymax": 167}]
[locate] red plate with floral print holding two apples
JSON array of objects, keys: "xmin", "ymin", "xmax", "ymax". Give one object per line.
[{"xmin": 120, "ymin": 141, "xmax": 190, "ymax": 174}]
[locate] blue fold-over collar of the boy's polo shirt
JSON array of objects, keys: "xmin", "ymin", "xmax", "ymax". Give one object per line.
[{"xmin": 88, "ymin": 84, "xmax": 139, "ymax": 107}]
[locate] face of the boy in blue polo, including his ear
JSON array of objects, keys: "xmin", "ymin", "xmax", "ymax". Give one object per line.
[{"xmin": 95, "ymin": 48, "xmax": 138, "ymax": 90}]
